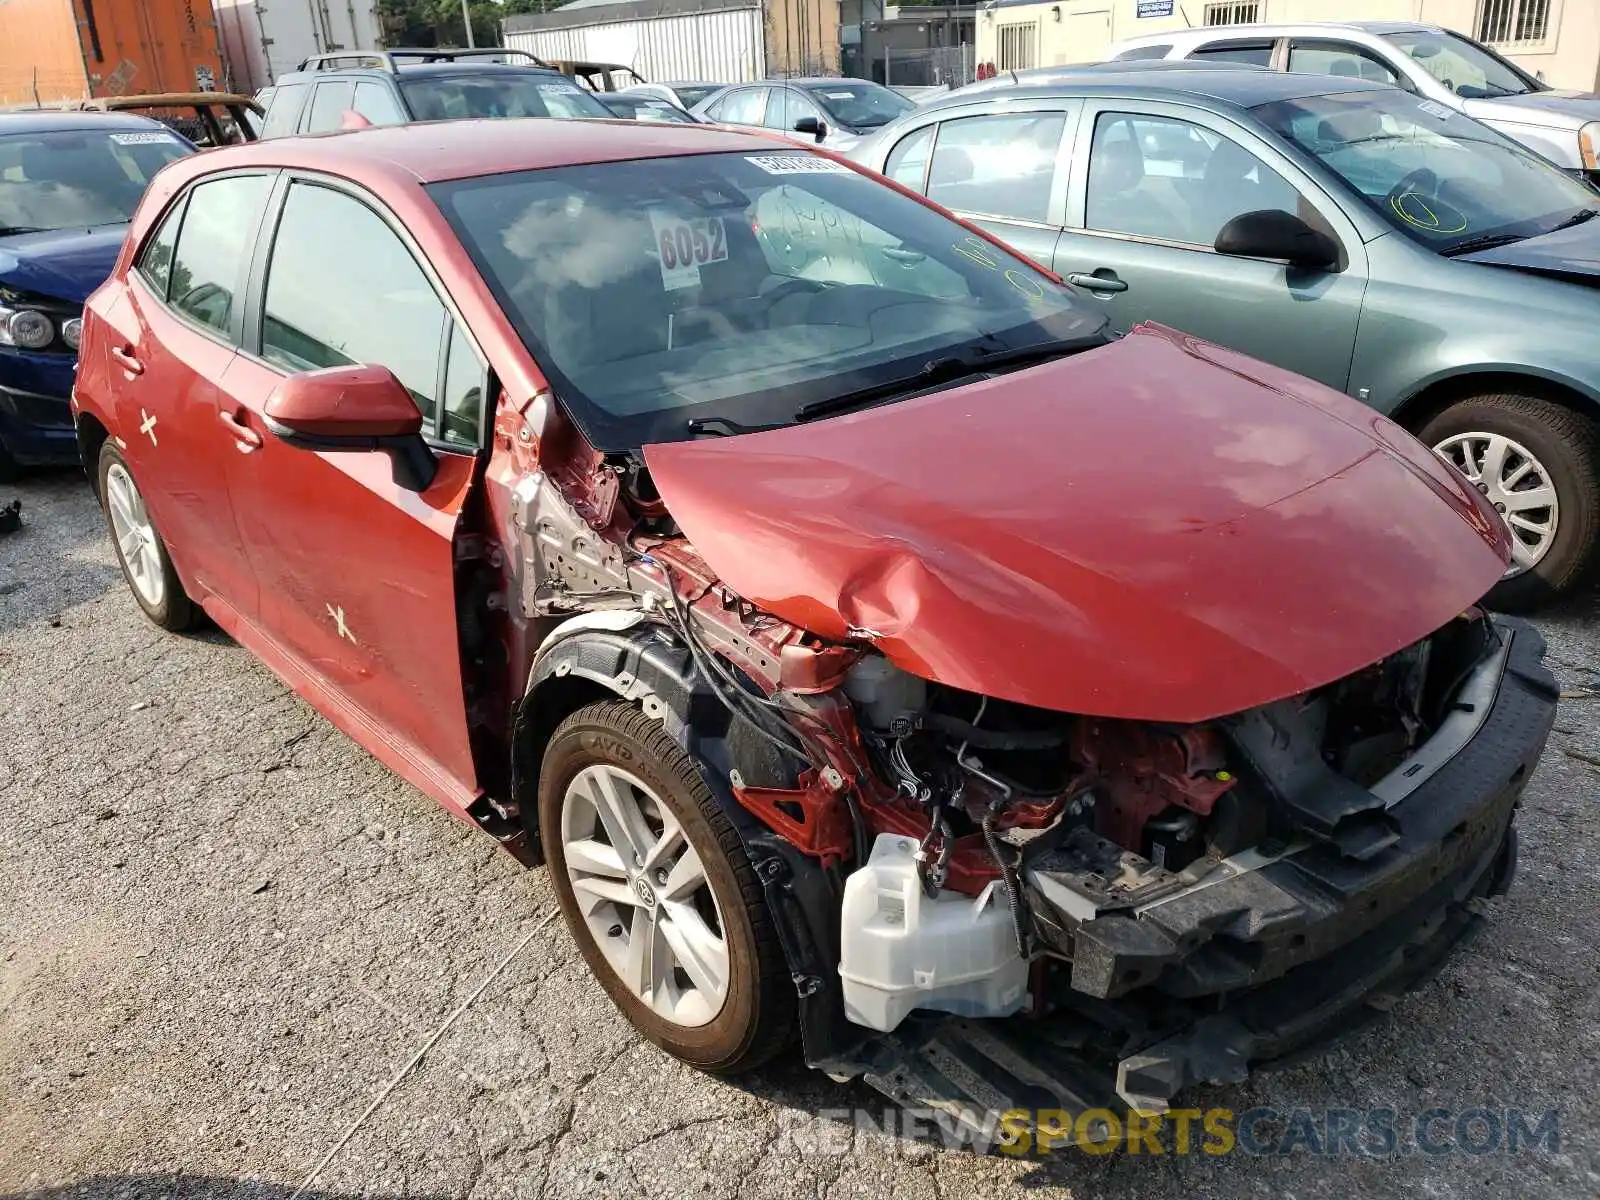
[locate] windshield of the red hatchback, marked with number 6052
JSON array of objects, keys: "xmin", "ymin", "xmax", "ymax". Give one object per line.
[{"xmin": 430, "ymin": 147, "xmax": 1104, "ymax": 451}]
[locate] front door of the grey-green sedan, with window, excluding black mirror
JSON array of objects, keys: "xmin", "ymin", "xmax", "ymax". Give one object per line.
[{"xmin": 1051, "ymin": 99, "xmax": 1366, "ymax": 390}]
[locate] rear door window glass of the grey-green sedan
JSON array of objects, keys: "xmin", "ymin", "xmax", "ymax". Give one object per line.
[{"xmin": 928, "ymin": 112, "xmax": 1066, "ymax": 221}]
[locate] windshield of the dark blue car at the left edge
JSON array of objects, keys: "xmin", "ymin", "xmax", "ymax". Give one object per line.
[{"xmin": 0, "ymin": 126, "xmax": 194, "ymax": 237}]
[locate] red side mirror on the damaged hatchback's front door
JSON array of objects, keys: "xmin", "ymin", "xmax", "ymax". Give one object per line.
[{"xmin": 262, "ymin": 365, "xmax": 438, "ymax": 491}]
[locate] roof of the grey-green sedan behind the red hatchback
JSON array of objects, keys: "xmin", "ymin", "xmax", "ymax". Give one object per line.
[{"xmin": 940, "ymin": 64, "xmax": 1389, "ymax": 110}]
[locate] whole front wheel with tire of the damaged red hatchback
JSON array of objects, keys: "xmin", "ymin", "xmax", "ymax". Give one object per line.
[{"xmin": 539, "ymin": 701, "xmax": 797, "ymax": 1075}]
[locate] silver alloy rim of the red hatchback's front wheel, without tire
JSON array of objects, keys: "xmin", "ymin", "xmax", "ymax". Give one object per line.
[{"xmin": 562, "ymin": 763, "xmax": 730, "ymax": 1027}]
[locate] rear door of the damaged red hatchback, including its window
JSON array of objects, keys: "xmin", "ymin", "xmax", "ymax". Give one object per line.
[{"xmin": 80, "ymin": 174, "xmax": 272, "ymax": 613}]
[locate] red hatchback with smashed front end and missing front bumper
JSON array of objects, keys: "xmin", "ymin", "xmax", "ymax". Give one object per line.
[{"xmin": 75, "ymin": 122, "xmax": 1555, "ymax": 1136}]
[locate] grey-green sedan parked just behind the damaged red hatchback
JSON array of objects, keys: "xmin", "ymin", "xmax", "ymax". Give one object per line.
[{"xmin": 851, "ymin": 64, "xmax": 1600, "ymax": 608}]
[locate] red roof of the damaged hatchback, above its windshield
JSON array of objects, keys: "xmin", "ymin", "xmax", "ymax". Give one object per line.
[{"xmin": 164, "ymin": 117, "xmax": 780, "ymax": 184}]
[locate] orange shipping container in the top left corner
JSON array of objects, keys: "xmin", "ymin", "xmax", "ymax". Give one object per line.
[{"xmin": 0, "ymin": 0, "xmax": 222, "ymax": 107}]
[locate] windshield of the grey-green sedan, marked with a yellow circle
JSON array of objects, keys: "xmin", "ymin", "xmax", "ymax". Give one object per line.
[{"xmin": 1256, "ymin": 90, "xmax": 1600, "ymax": 254}]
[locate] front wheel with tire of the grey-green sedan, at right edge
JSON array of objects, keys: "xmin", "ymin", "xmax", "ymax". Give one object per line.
[{"xmin": 1418, "ymin": 392, "xmax": 1600, "ymax": 613}]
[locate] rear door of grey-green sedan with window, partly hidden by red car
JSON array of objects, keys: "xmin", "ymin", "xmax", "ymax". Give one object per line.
[{"xmin": 883, "ymin": 99, "xmax": 1083, "ymax": 267}]
